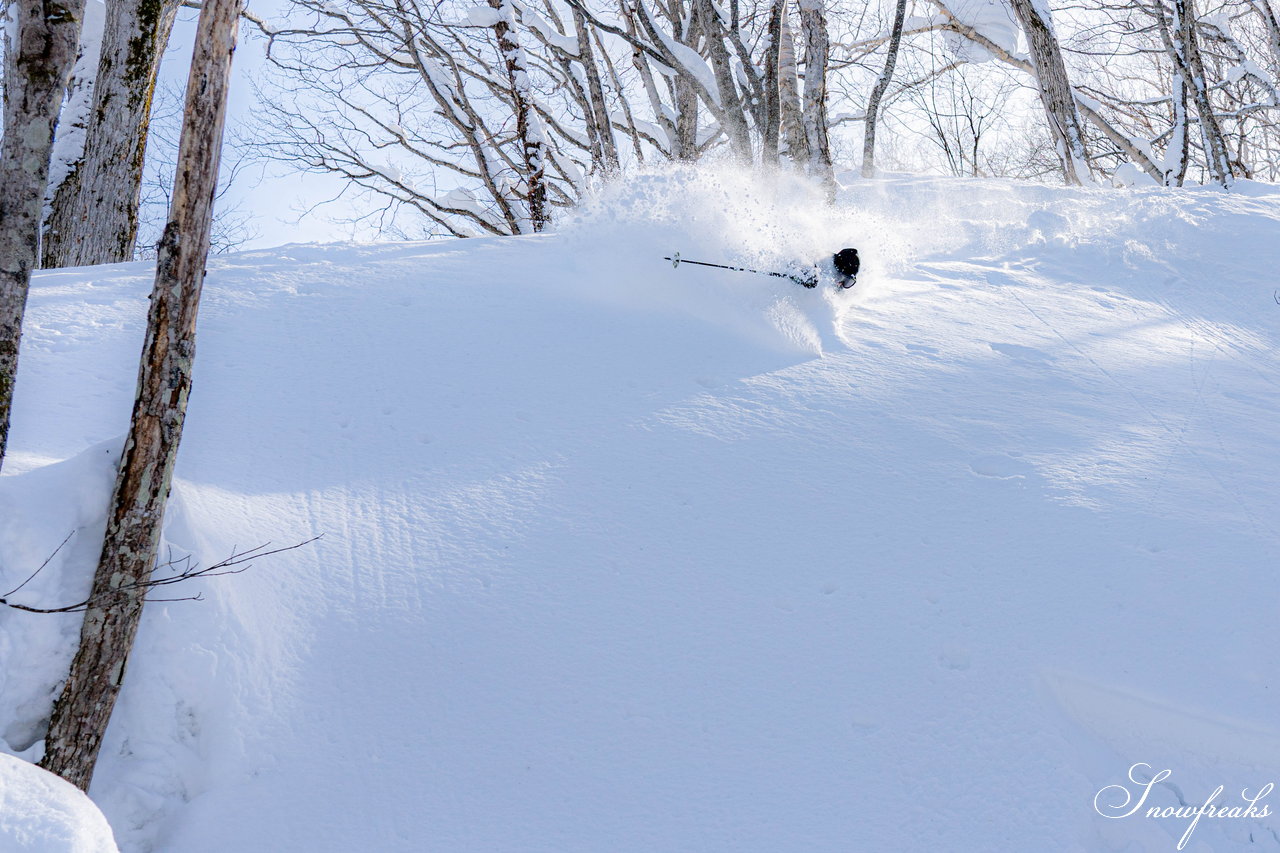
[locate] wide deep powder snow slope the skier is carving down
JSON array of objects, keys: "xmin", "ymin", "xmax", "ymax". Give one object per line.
[{"xmin": 0, "ymin": 173, "xmax": 1280, "ymax": 853}]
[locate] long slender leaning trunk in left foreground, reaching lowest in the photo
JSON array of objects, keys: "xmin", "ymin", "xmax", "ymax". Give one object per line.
[{"xmin": 40, "ymin": 0, "xmax": 243, "ymax": 790}]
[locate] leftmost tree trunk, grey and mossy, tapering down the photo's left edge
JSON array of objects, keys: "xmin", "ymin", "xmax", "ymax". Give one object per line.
[{"xmin": 0, "ymin": 0, "xmax": 84, "ymax": 464}]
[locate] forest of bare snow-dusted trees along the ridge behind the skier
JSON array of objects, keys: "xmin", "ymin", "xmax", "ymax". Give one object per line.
[{"xmin": 251, "ymin": 0, "xmax": 1280, "ymax": 236}]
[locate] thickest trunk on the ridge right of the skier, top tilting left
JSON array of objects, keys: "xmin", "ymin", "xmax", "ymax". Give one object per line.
[{"xmin": 1010, "ymin": 0, "xmax": 1089, "ymax": 184}]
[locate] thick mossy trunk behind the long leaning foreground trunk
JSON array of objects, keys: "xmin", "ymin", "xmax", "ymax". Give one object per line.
[{"xmin": 44, "ymin": 0, "xmax": 178, "ymax": 266}]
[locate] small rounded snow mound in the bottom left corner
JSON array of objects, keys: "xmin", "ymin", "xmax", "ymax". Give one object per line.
[{"xmin": 0, "ymin": 753, "xmax": 116, "ymax": 853}]
